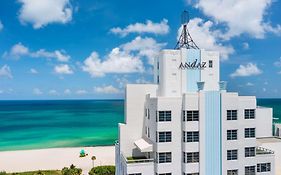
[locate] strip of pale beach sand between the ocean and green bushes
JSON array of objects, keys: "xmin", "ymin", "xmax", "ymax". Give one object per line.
[{"xmin": 0, "ymin": 146, "xmax": 115, "ymax": 174}]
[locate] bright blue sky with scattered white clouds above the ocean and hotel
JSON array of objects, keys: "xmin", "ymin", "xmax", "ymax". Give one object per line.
[{"xmin": 0, "ymin": 0, "xmax": 281, "ymax": 100}]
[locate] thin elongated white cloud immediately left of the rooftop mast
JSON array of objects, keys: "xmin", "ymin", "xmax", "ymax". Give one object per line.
[{"xmin": 110, "ymin": 19, "xmax": 169, "ymax": 37}]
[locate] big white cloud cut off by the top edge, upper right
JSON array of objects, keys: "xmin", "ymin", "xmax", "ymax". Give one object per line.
[{"xmin": 191, "ymin": 0, "xmax": 281, "ymax": 39}]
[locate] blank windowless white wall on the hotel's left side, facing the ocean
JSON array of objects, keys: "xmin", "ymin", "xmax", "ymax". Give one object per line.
[{"xmin": 119, "ymin": 84, "xmax": 158, "ymax": 157}]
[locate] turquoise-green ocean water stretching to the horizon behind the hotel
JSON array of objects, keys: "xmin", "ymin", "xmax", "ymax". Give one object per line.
[{"xmin": 0, "ymin": 99, "xmax": 281, "ymax": 151}]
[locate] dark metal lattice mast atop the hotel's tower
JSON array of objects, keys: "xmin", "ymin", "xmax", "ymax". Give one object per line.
[{"xmin": 175, "ymin": 10, "xmax": 199, "ymax": 49}]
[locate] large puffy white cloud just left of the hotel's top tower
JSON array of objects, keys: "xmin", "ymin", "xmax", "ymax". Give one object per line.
[{"xmin": 82, "ymin": 37, "xmax": 166, "ymax": 77}]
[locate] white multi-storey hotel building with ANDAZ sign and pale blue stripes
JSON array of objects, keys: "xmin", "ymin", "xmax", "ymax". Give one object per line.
[{"xmin": 116, "ymin": 12, "xmax": 275, "ymax": 175}]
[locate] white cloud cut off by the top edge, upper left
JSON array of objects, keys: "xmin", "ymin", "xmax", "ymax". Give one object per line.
[{"xmin": 18, "ymin": 0, "xmax": 73, "ymax": 29}]
